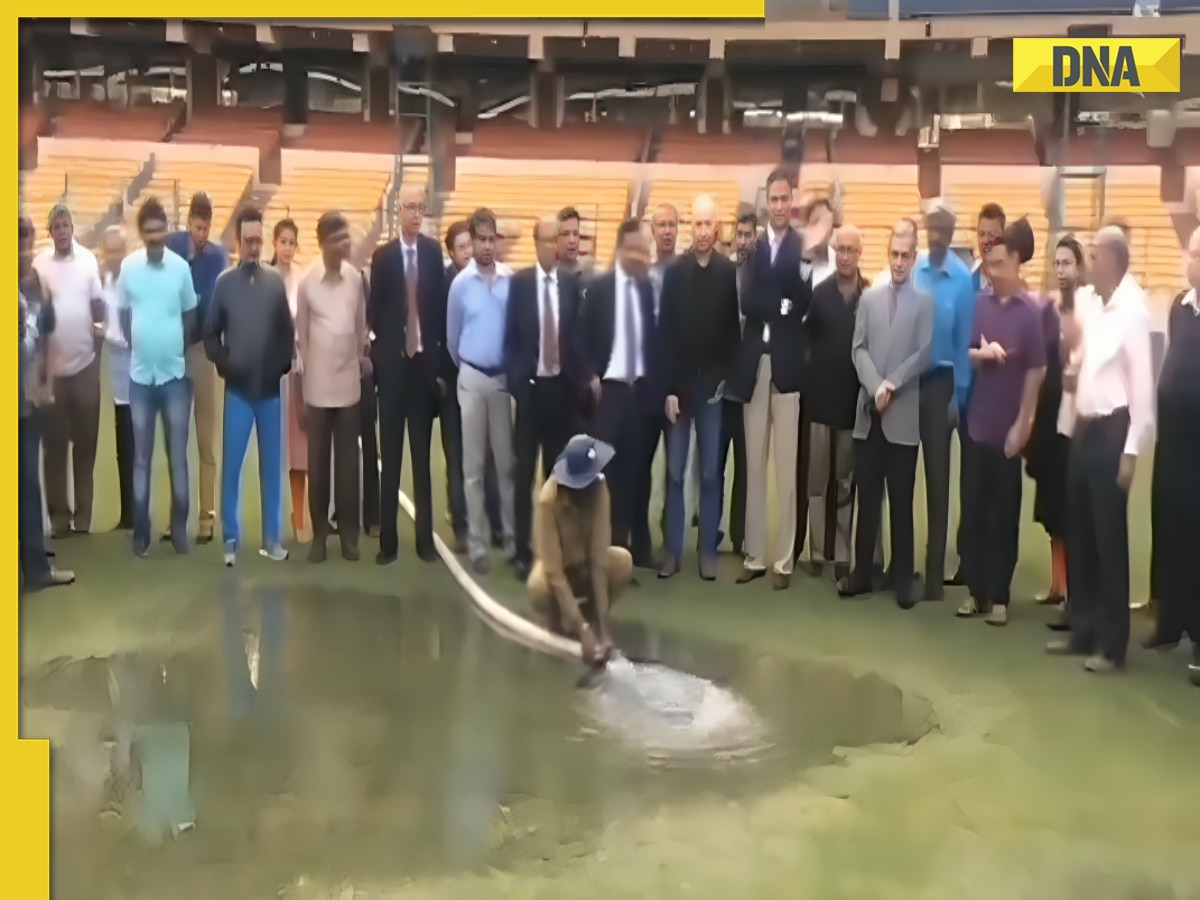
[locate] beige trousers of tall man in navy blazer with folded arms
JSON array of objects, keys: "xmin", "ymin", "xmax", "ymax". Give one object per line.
[{"xmin": 744, "ymin": 353, "xmax": 800, "ymax": 575}]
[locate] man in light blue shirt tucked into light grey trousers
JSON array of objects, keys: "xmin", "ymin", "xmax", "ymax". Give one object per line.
[{"xmin": 446, "ymin": 209, "xmax": 516, "ymax": 574}]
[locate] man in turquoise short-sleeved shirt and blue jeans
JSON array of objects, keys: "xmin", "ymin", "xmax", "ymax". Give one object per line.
[{"xmin": 118, "ymin": 197, "xmax": 196, "ymax": 557}]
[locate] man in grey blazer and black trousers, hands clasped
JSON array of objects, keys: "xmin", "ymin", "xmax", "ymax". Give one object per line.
[{"xmin": 838, "ymin": 221, "xmax": 934, "ymax": 610}]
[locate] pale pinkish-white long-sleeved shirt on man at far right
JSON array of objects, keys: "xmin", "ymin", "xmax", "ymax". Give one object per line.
[{"xmin": 1075, "ymin": 275, "xmax": 1154, "ymax": 456}]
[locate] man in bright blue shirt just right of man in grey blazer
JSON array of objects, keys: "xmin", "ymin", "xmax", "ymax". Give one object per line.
[{"xmin": 913, "ymin": 200, "xmax": 976, "ymax": 600}]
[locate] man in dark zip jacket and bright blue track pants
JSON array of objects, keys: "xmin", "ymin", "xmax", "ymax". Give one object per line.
[{"xmin": 204, "ymin": 206, "xmax": 295, "ymax": 566}]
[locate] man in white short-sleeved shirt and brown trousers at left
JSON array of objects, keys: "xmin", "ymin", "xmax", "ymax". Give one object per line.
[{"xmin": 34, "ymin": 203, "xmax": 106, "ymax": 536}]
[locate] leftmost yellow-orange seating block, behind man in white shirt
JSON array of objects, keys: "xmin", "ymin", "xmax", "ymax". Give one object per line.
[{"xmin": 20, "ymin": 156, "xmax": 143, "ymax": 246}]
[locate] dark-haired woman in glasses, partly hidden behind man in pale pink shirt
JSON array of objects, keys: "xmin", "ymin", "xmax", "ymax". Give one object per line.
[{"xmin": 1030, "ymin": 234, "xmax": 1085, "ymax": 630}]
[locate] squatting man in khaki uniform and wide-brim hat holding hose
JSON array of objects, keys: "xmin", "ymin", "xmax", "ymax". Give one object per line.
[{"xmin": 527, "ymin": 434, "xmax": 634, "ymax": 665}]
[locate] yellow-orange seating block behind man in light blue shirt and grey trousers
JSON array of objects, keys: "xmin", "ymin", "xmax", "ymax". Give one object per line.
[{"xmin": 442, "ymin": 174, "xmax": 629, "ymax": 268}]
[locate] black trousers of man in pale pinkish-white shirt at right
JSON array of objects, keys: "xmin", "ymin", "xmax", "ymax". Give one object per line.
[{"xmin": 1067, "ymin": 409, "xmax": 1129, "ymax": 665}]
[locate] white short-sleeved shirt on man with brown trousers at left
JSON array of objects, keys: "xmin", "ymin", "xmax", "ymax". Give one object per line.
[{"xmin": 34, "ymin": 242, "xmax": 103, "ymax": 377}]
